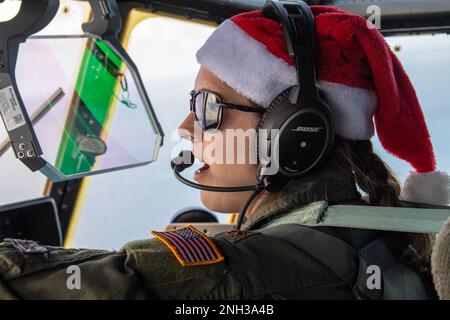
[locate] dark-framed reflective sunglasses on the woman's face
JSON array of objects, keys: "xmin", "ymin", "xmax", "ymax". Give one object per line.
[{"xmin": 190, "ymin": 90, "xmax": 265, "ymax": 131}]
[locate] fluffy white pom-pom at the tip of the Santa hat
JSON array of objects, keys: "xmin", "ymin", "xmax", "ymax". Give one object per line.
[{"xmin": 400, "ymin": 171, "xmax": 450, "ymax": 206}]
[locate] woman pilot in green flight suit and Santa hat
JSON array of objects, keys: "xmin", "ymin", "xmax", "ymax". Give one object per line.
[{"xmin": 0, "ymin": 6, "xmax": 449, "ymax": 299}]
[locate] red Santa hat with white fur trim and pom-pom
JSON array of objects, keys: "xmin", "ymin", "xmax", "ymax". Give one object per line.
[{"xmin": 197, "ymin": 6, "xmax": 450, "ymax": 205}]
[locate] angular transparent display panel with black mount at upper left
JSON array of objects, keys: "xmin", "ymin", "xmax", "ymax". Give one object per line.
[{"xmin": 0, "ymin": 0, "xmax": 163, "ymax": 182}]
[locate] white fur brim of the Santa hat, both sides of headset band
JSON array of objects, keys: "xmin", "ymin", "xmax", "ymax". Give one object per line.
[{"xmin": 197, "ymin": 20, "xmax": 377, "ymax": 140}]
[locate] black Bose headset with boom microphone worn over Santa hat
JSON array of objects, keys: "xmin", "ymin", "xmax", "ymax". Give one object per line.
[{"xmin": 171, "ymin": 0, "xmax": 335, "ymax": 229}]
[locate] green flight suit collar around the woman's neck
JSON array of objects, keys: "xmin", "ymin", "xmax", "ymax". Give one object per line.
[{"xmin": 242, "ymin": 164, "xmax": 361, "ymax": 230}]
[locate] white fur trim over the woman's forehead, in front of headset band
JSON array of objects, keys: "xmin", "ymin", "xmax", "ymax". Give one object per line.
[{"xmin": 197, "ymin": 20, "xmax": 296, "ymax": 107}]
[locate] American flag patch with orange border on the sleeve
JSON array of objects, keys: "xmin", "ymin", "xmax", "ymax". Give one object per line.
[{"xmin": 152, "ymin": 225, "xmax": 224, "ymax": 267}]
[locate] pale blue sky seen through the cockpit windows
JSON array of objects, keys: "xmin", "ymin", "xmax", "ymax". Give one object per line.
[{"xmin": 0, "ymin": 2, "xmax": 450, "ymax": 249}]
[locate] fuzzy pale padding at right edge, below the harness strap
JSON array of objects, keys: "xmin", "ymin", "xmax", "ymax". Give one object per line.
[{"xmin": 431, "ymin": 218, "xmax": 450, "ymax": 300}]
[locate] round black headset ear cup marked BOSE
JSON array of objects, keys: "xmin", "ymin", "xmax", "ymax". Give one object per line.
[{"xmin": 256, "ymin": 88, "xmax": 334, "ymax": 183}]
